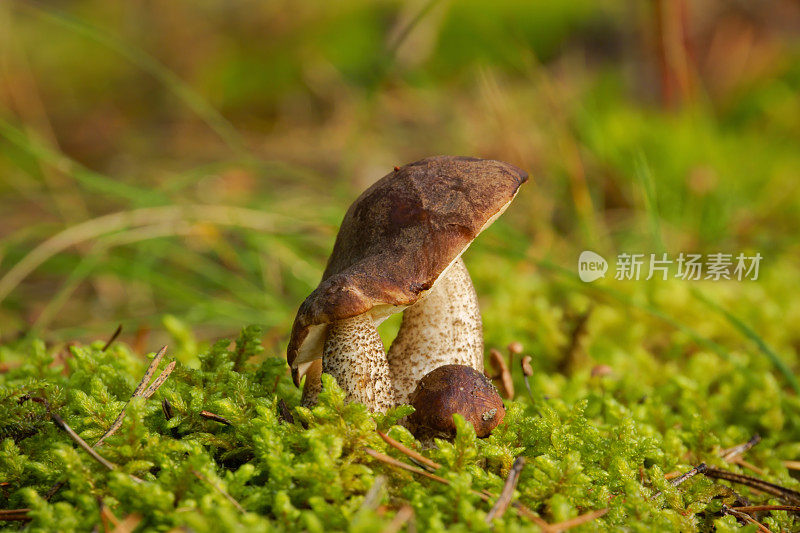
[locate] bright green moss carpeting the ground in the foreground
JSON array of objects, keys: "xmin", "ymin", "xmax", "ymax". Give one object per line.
[{"xmin": 0, "ymin": 322, "xmax": 800, "ymax": 531}]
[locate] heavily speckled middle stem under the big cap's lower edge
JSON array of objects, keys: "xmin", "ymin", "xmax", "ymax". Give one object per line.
[{"xmin": 318, "ymin": 313, "xmax": 395, "ymax": 412}]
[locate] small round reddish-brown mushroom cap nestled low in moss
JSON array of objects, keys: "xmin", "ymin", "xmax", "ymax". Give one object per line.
[{"xmin": 408, "ymin": 365, "xmax": 506, "ymax": 438}]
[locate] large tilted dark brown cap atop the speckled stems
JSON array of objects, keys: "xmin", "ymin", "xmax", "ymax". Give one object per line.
[{"xmin": 286, "ymin": 156, "xmax": 528, "ymax": 383}]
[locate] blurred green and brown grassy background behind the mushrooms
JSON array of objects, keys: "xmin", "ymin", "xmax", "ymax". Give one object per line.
[{"xmin": 0, "ymin": 0, "xmax": 800, "ymax": 380}]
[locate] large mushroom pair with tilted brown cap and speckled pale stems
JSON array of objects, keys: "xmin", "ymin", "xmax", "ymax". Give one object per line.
[{"xmin": 286, "ymin": 156, "xmax": 527, "ymax": 411}]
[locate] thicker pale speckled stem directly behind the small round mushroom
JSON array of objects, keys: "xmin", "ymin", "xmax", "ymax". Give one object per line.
[{"xmin": 388, "ymin": 257, "xmax": 483, "ymax": 404}]
